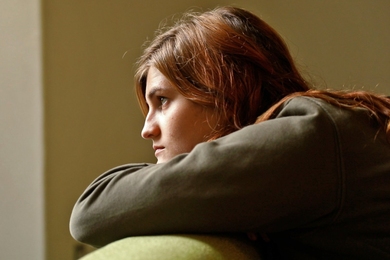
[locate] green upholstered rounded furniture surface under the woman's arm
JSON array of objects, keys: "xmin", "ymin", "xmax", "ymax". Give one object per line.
[{"xmin": 81, "ymin": 235, "xmax": 260, "ymax": 260}]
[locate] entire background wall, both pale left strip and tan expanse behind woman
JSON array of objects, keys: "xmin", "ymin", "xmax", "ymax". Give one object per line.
[{"xmin": 0, "ymin": 0, "xmax": 390, "ymax": 260}]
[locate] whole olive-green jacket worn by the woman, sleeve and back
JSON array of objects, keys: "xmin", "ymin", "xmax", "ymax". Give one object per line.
[{"xmin": 70, "ymin": 97, "xmax": 390, "ymax": 259}]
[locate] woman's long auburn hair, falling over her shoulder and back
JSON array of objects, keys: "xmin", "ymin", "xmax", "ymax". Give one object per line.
[{"xmin": 135, "ymin": 7, "xmax": 390, "ymax": 140}]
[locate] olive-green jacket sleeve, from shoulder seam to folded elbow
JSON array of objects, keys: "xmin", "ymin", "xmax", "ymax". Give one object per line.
[{"xmin": 70, "ymin": 98, "xmax": 341, "ymax": 247}]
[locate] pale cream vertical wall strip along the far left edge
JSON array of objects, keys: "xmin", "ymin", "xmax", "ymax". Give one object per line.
[{"xmin": 0, "ymin": 0, "xmax": 44, "ymax": 260}]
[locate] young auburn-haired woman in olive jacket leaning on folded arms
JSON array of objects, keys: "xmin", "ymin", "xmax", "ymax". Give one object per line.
[{"xmin": 70, "ymin": 7, "xmax": 390, "ymax": 259}]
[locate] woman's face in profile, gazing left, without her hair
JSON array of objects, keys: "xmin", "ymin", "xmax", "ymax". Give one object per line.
[{"xmin": 141, "ymin": 67, "xmax": 216, "ymax": 163}]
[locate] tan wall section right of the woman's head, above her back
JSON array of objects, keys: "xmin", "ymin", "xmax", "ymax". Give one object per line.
[{"xmin": 250, "ymin": 0, "xmax": 390, "ymax": 95}]
